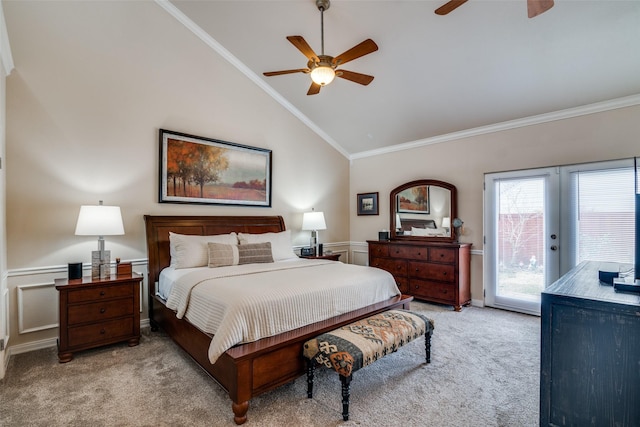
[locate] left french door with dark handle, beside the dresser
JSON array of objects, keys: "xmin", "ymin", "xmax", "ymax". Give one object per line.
[{"xmin": 484, "ymin": 168, "xmax": 560, "ymax": 314}]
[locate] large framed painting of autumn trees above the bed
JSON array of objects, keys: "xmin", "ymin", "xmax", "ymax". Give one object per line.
[{"xmin": 160, "ymin": 129, "xmax": 271, "ymax": 207}]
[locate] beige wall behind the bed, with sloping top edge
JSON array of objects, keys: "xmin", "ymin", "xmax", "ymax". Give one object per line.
[{"xmin": 4, "ymin": 1, "xmax": 349, "ymax": 352}]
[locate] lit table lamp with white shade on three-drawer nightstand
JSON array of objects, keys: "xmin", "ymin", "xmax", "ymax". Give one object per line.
[{"xmin": 75, "ymin": 200, "xmax": 124, "ymax": 279}]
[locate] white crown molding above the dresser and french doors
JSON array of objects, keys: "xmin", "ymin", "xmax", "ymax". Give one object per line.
[{"xmin": 349, "ymin": 94, "xmax": 640, "ymax": 161}]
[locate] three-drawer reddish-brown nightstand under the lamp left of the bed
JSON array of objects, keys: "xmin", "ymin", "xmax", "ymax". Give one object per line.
[{"xmin": 55, "ymin": 273, "xmax": 142, "ymax": 363}]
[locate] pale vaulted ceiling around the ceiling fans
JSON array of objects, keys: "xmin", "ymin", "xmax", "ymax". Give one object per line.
[{"xmin": 159, "ymin": 0, "xmax": 640, "ymax": 157}]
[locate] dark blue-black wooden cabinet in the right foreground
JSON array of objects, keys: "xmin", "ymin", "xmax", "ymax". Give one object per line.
[{"xmin": 540, "ymin": 262, "xmax": 640, "ymax": 427}]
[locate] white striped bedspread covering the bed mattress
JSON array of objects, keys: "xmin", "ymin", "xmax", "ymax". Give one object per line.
[{"xmin": 161, "ymin": 259, "xmax": 400, "ymax": 363}]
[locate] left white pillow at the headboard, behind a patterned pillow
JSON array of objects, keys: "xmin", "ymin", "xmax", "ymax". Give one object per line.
[{"xmin": 169, "ymin": 232, "xmax": 238, "ymax": 269}]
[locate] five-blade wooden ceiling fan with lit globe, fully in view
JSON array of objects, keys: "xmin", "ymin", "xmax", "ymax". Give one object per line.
[{"xmin": 263, "ymin": 0, "xmax": 378, "ymax": 95}]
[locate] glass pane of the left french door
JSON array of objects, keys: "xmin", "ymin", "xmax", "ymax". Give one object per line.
[{"xmin": 496, "ymin": 177, "xmax": 545, "ymax": 301}]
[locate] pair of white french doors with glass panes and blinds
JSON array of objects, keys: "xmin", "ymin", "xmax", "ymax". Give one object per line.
[{"xmin": 484, "ymin": 159, "xmax": 635, "ymax": 314}]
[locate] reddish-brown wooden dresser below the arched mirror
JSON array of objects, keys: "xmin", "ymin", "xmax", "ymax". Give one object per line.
[{"xmin": 367, "ymin": 240, "xmax": 471, "ymax": 311}]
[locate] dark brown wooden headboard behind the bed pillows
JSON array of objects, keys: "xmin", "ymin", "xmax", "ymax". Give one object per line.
[{"xmin": 144, "ymin": 215, "xmax": 285, "ymax": 295}]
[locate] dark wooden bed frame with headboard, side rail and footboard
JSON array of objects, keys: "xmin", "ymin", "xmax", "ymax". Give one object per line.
[{"xmin": 144, "ymin": 215, "xmax": 413, "ymax": 424}]
